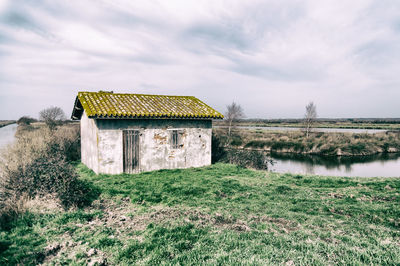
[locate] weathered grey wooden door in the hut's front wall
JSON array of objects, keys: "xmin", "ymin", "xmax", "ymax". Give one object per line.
[{"xmin": 123, "ymin": 130, "xmax": 139, "ymax": 174}]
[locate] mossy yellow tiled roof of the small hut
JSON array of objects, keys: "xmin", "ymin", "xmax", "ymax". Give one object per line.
[{"xmin": 72, "ymin": 91, "xmax": 224, "ymax": 119}]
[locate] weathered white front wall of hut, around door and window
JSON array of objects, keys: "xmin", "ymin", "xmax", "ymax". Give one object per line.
[{"xmin": 94, "ymin": 119, "xmax": 212, "ymax": 174}]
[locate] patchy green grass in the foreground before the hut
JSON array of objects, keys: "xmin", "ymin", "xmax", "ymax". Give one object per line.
[{"xmin": 0, "ymin": 164, "xmax": 400, "ymax": 265}]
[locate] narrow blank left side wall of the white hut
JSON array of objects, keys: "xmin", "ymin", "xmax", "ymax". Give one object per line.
[{"xmin": 81, "ymin": 112, "xmax": 99, "ymax": 173}]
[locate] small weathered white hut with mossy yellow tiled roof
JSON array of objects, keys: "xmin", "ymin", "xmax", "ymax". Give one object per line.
[{"xmin": 72, "ymin": 91, "xmax": 223, "ymax": 174}]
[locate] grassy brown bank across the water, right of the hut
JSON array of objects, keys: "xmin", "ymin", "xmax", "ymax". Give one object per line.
[{"xmin": 213, "ymin": 128, "xmax": 400, "ymax": 156}]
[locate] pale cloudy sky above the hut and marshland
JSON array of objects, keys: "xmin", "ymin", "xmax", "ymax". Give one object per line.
[{"xmin": 0, "ymin": 0, "xmax": 400, "ymax": 120}]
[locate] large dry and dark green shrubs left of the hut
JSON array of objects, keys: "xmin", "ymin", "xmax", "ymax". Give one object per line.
[{"xmin": 0, "ymin": 127, "xmax": 98, "ymax": 228}]
